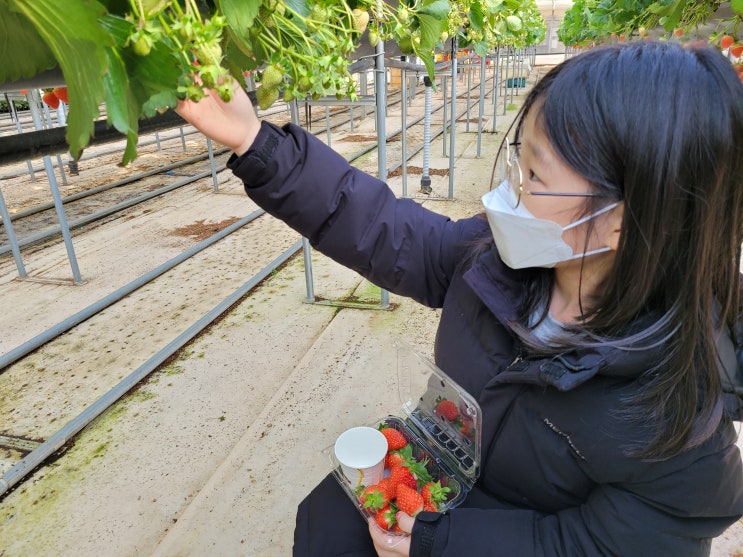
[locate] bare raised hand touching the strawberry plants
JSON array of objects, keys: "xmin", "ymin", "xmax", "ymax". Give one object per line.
[{"xmin": 175, "ymin": 81, "xmax": 261, "ymax": 155}]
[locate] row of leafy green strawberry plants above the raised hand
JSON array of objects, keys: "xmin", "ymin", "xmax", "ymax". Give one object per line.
[{"xmin": 0, "ymin": 0, "xmax": 544, "ymax": 164}]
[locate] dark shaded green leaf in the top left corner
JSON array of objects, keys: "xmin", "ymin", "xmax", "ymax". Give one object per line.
[{"xmin": 0, "ymin": 7, "xmax": 57, "ymax": 83}]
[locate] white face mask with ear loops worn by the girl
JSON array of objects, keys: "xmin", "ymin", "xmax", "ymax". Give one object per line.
[{"xmin": 482, "ymin": 181, "xmax": 619, "ymax": 269}]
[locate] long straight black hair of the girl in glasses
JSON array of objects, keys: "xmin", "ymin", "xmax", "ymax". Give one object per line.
[{"xmin": 506, "ymin": 42, "xmax": 743, "ymax": 458}]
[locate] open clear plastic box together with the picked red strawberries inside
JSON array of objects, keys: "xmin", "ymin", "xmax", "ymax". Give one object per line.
[{"xmin": 324, "ymin": 340, "xmax": 482, "ymax": 539}]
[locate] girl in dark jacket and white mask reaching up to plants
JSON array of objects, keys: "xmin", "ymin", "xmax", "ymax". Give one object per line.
[{"xmin": 178, "ymin": 42, "xmax": 743, "ymax": 556}]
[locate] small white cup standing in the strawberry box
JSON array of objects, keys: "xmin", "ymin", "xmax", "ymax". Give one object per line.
[{"xmin": 335, "ymin": 426, "xmax": 387, "ymax": 490}]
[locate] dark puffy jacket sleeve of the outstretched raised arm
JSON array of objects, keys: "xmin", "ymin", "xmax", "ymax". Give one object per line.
[{"xmin": 228, "ymin": 122, "xmax": 487, "ymax": 307}]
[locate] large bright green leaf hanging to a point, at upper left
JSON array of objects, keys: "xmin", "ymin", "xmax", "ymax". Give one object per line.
[{"xmin": 8, "ymin": 0, "xmax": 113, "ymax": 157}]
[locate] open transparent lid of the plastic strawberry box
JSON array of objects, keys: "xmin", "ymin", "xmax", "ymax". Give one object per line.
[{"xmin": 394, "ymin": 339, "xmax": 482, "ymax": 487}]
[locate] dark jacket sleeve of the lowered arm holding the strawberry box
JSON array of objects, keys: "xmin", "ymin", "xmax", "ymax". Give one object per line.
[{"xmin": 418, "ymin": 436, "xmax": 743, "ymax": 557}]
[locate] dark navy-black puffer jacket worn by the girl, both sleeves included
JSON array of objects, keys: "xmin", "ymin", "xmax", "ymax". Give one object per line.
[{"xmin": 228, "ymin": 123, "xmax": 743, "ymax": 557}]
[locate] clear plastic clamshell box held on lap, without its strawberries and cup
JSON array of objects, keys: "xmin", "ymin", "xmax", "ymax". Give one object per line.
[{"xmin": 323, "ymin": 339, "xmax": 482, "ymax": 544}]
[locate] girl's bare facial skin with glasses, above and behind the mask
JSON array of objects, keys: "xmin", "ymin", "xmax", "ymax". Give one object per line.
[{"xmin": 519, "ymin": 107, "xmax": 622, "ymax": 266}]
